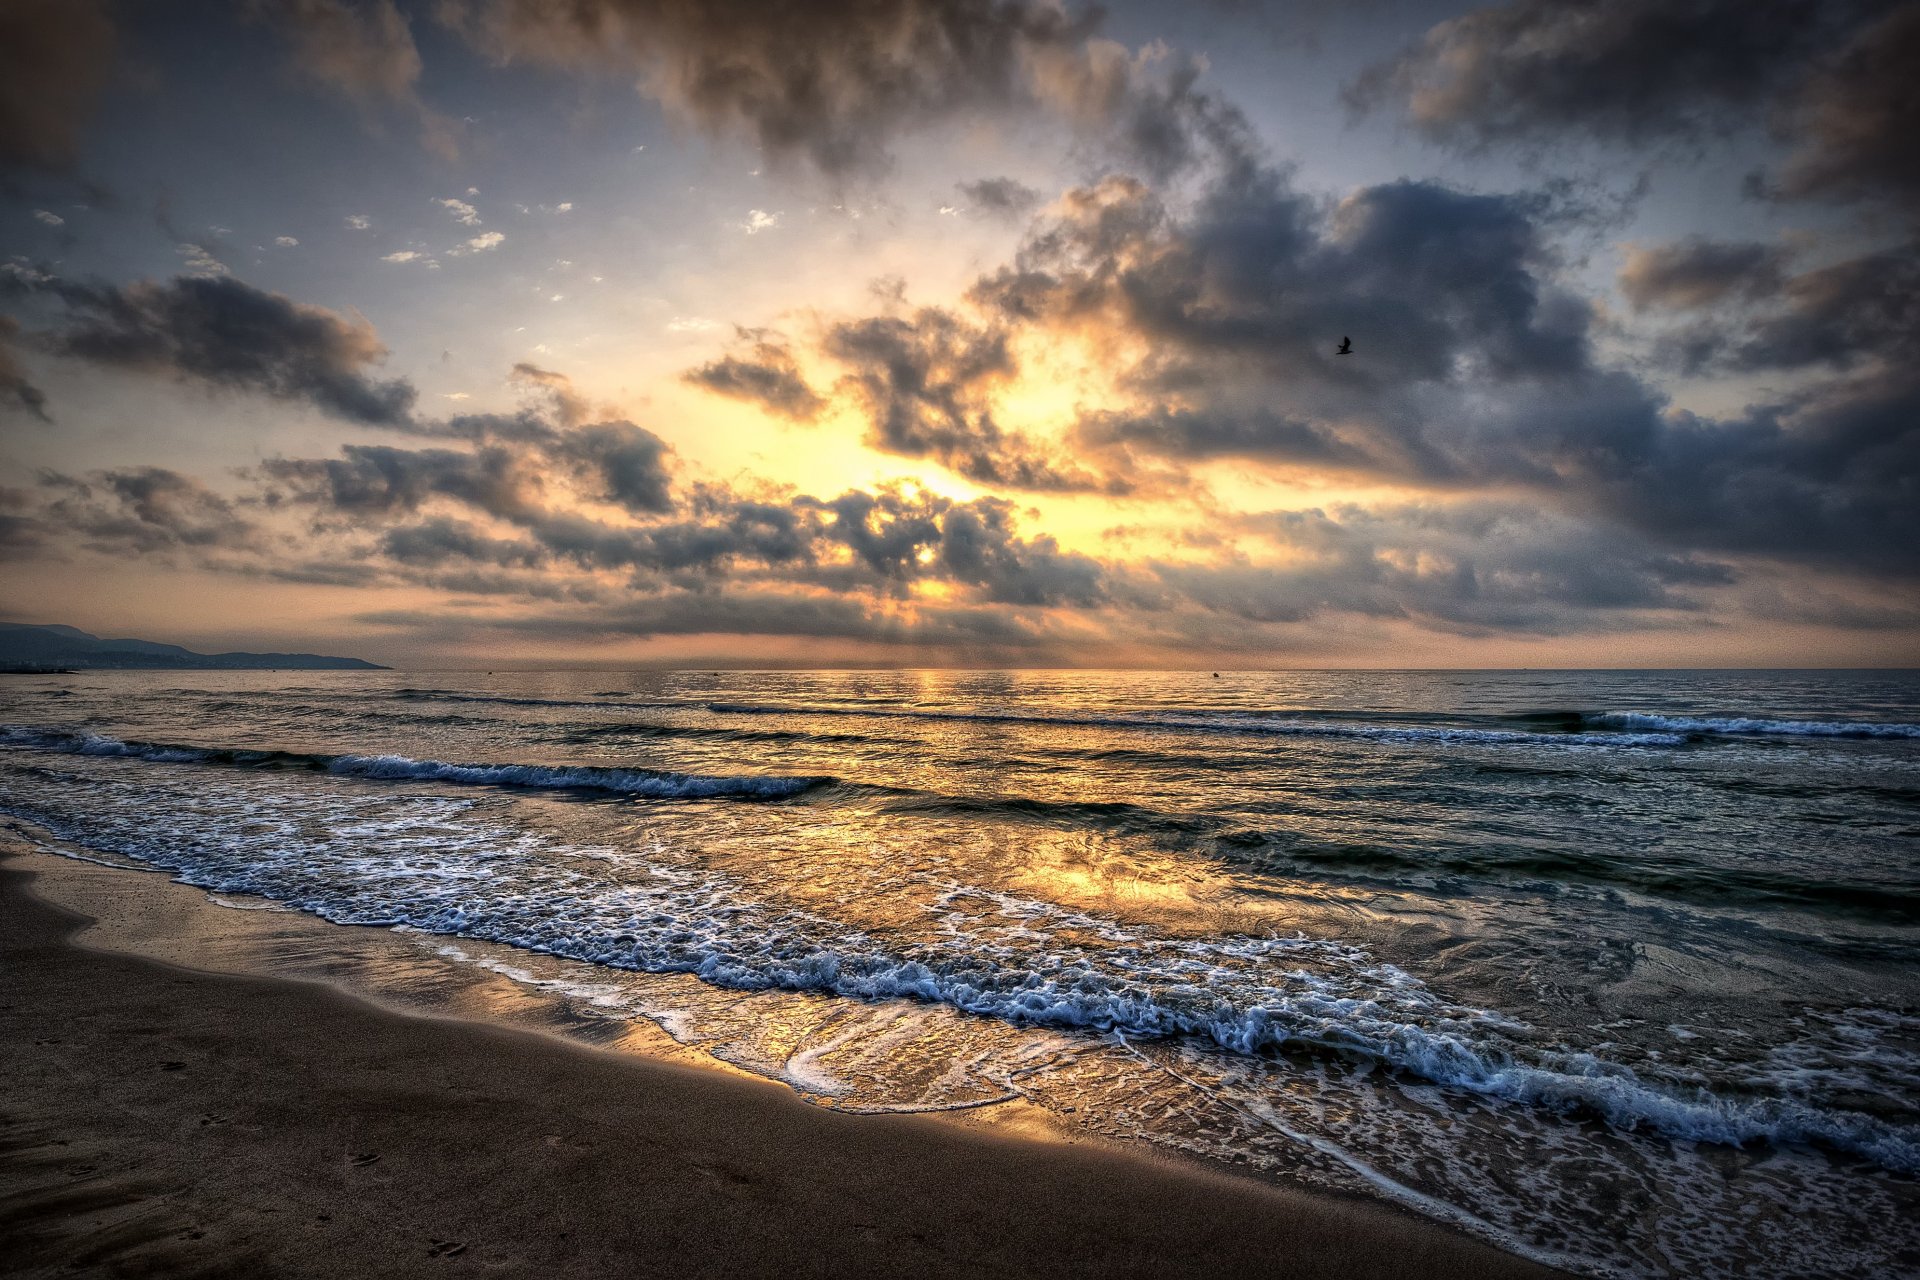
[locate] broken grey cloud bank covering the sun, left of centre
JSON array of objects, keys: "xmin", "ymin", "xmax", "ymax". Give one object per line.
[{"xmin": 240, "ymin": 393, "xmax": 1106, "ymax": 606}]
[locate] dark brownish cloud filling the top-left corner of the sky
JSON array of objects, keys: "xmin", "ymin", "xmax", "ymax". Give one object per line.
[{"xmin": 0, "ymin": 0, "xmax": 115, "ymax": 171}]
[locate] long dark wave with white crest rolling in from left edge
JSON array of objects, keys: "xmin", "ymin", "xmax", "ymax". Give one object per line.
[{"xmin": 0, "ymin": 725, "xmax": 835, "ymax": 800}]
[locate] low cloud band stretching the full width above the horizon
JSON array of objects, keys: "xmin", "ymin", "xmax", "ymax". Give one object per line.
[{"xmin": 15, "ymin": 378, "xmax": 1912, "ymax": 660}]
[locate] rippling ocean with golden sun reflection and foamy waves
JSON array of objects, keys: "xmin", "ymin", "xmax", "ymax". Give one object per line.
[{"xmin": 0, "ymin": 672, "xmax": 1920, "ymax": 1276}]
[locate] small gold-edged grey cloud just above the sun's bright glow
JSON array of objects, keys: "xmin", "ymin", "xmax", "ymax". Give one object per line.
[{"xmin": 822, "ymin": 307, "xmax": 1117, "ymax": 491}]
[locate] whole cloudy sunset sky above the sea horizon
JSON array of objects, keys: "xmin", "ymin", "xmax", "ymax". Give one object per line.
[{"xmin": 0, "ymin": 0, "xmax": 1920, "ymax": 670}]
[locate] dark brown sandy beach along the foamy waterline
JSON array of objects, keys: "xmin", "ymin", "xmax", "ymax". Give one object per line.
[{"xmin": 0, "ymin": 840, "xmax": 1557, "ymax": 1278}]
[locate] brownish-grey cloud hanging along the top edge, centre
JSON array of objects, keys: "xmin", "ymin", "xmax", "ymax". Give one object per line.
[{"xmin": 438, "ymin": 0, "xmax": 1238, "ymax": 177}]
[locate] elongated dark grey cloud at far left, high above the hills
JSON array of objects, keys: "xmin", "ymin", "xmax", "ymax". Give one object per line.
[{"xmin": 0, "ymin": 273, "xmax": 415, "ymax": 426}]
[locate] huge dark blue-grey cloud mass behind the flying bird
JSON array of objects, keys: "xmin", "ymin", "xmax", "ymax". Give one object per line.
[{"xmin": 752, "ymin": 136, "xmax": 1920, "ymax": 576}]
